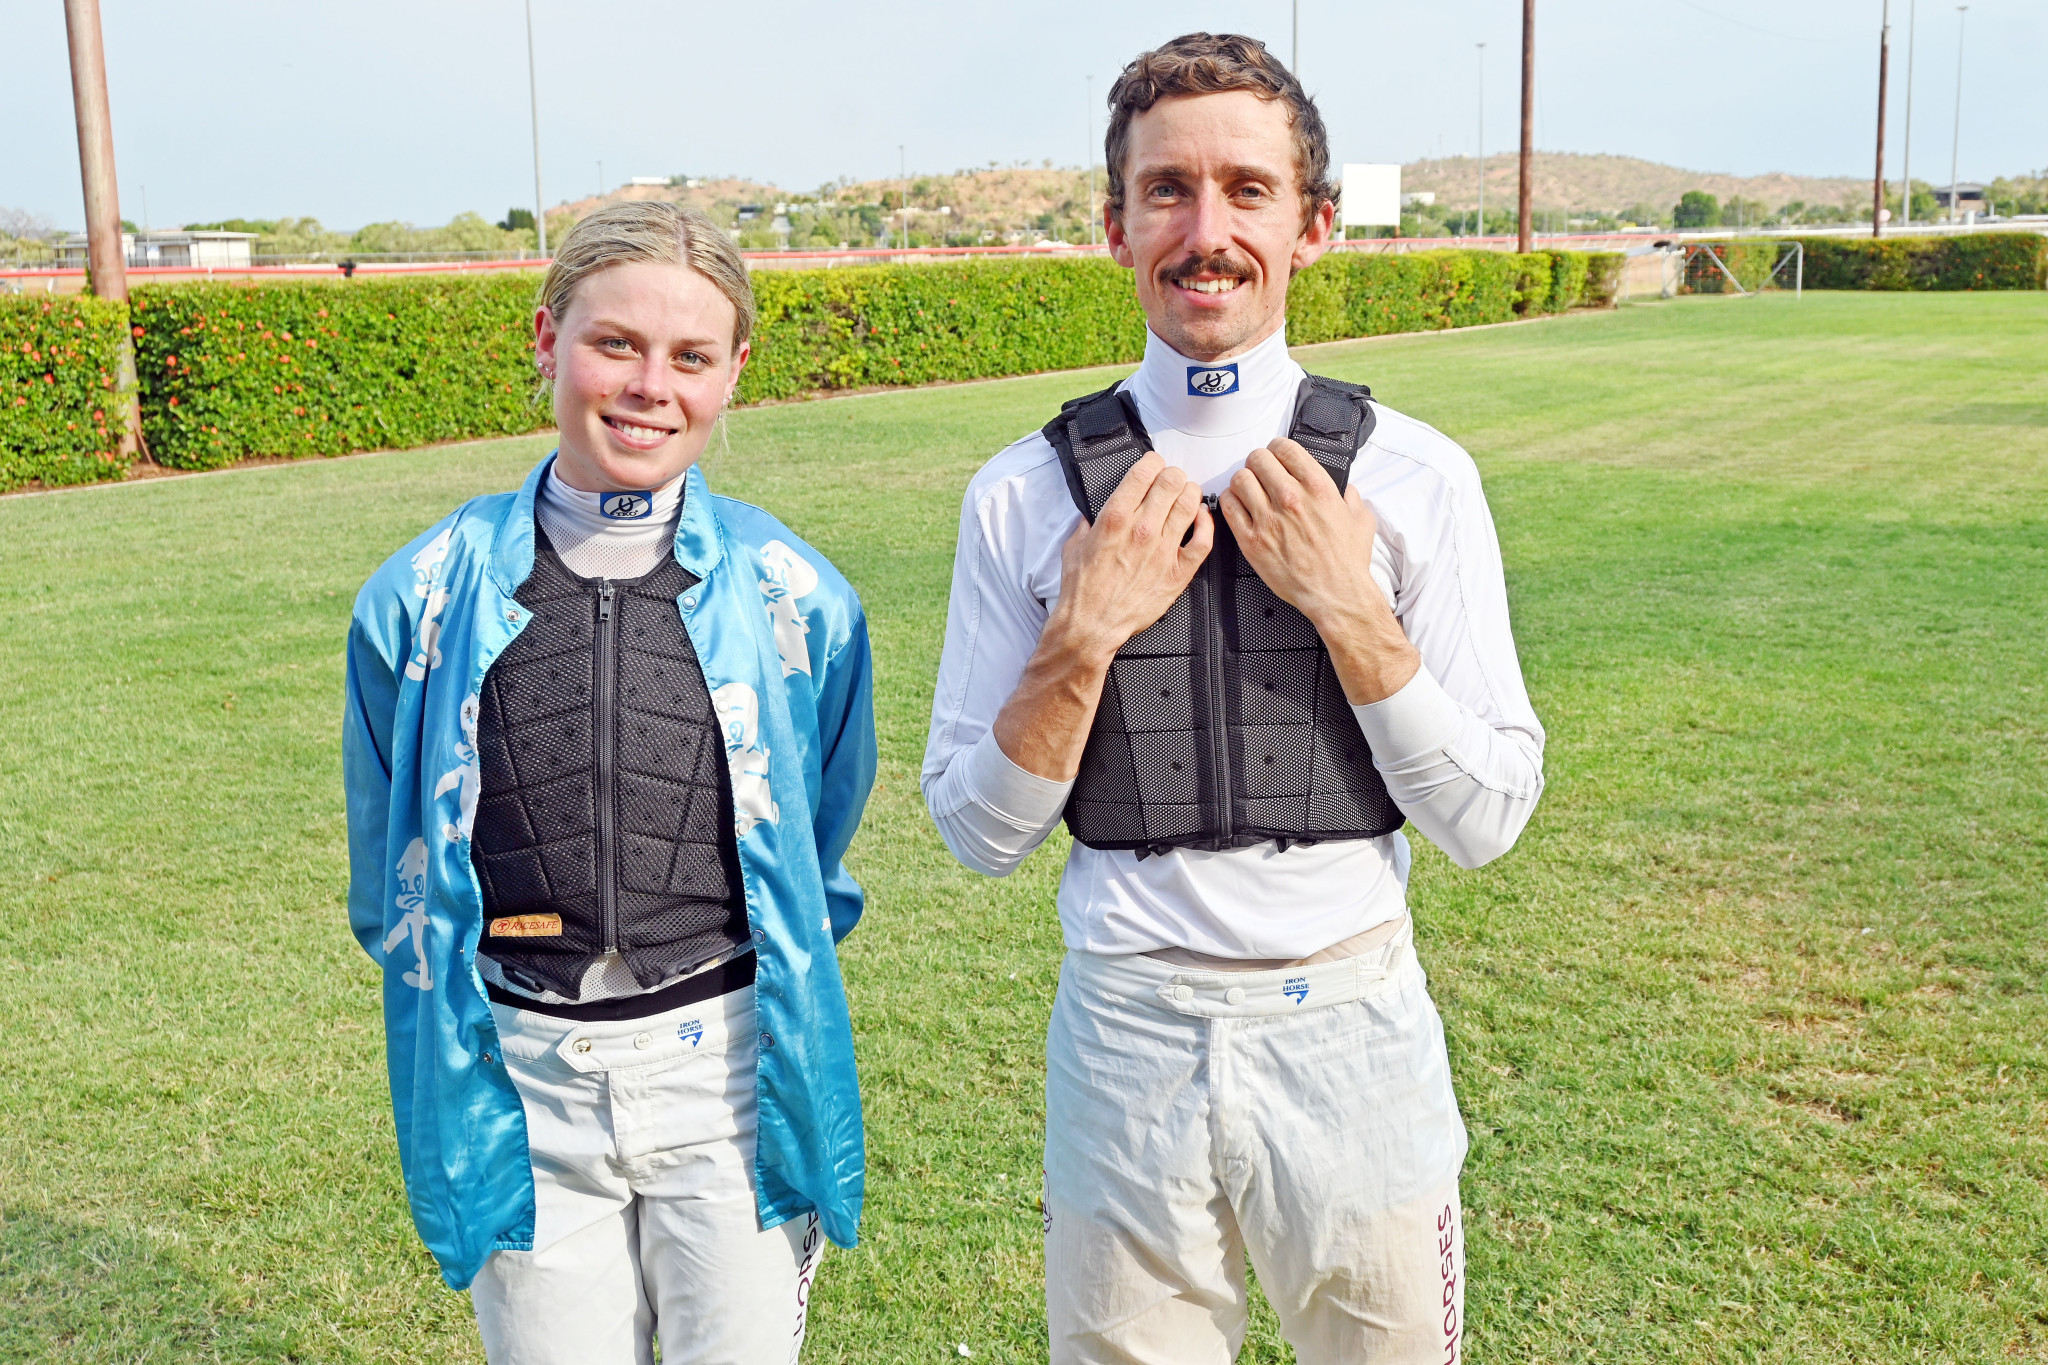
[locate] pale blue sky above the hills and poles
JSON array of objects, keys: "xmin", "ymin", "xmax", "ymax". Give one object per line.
[{"xmin": 0, "ymin": 0, "xmax": 2048, "ymax": 227}]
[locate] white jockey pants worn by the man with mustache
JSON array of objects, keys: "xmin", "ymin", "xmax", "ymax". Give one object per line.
[{"xmin": 1044, "ymin": 916, "xmax": 1466, "ymax": 1365}]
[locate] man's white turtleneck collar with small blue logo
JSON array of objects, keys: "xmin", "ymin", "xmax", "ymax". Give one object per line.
[{"xmin": 1124, "ymin": 327, "xmax": 1305, "ymax": 493}]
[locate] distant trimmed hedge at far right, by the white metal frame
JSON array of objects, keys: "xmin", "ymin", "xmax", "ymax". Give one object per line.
[{"xmin": 1683, "ymin": 231, "xmax": 2048, "ymax": 295}]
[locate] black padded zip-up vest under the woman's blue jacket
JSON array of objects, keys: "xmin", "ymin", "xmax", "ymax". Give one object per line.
[{"xmin": 471, "ymin": 524, "xmax": 748, "ymax": 1001}]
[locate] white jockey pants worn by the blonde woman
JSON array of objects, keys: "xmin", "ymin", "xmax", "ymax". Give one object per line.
[{"xmin": 471, "ymin": 986, "xmax": 823, "ymax": 1365}]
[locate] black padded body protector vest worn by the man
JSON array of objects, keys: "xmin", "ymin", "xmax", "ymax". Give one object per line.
[{"xmin": 1044, "ymin": 375, "xmax": 1405, "ymax": 857}]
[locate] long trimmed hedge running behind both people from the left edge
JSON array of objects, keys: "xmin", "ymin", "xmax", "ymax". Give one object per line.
[{"xmin": 0, "ymin": 252, "xmax": 1618, "ymax": 489}]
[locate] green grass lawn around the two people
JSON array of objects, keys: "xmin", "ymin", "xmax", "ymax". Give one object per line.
[{"xmin": 0, "ymin": 295, "xmax": 2048, "ymax": 1363}]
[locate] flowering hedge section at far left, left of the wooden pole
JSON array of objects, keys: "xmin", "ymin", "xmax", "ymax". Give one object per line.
[{"xmin": 0, "ymin": 295, "xmax": 129, "ymax": 489}]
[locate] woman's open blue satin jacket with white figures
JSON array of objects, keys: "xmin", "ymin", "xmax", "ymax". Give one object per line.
[{"xmin": 342, "ymin": 456, "xmax": 874, "ymax": 1289}]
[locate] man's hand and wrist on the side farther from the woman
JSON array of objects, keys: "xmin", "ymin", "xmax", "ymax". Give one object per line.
[{"xmin": 1219, "ymin": 438, "xmax": 1421, "ymax": 706}]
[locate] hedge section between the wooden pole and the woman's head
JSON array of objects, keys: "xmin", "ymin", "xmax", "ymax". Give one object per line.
[{"xmin": 133, "ymin": 270, "xmax": 553, "ymax": 469}]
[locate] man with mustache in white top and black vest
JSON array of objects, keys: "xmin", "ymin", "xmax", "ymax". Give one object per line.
[{"xmin": 924, "ymin": 33, "xmax": 1544, "ymax": 1365}]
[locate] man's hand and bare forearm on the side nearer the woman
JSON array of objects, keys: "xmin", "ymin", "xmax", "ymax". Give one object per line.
[{"xmin": 995, "ymin": 454, "xmax": 1217, "ymax": 782}]
